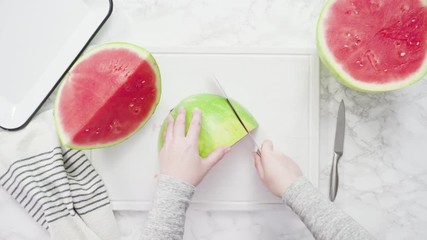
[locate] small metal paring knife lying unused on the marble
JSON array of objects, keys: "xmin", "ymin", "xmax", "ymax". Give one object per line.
[{"xmin": 329, "ymin": 100, "xmax": 345, "ymax": 202}]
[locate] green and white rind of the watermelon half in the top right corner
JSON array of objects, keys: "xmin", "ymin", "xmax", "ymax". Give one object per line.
[{"xmin": 316, "ymin": 0, "xmax": 427, "ymax": 92}]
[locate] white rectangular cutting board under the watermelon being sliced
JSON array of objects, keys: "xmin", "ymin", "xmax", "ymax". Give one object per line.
[{"xmin": 91, "ymin": 49, "xmax": 319, "ymax": 210}]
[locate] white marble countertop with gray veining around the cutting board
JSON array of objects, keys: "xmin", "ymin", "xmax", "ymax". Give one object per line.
[{"xmin": 0, "ymin": 0, "xmax": 427, "ymax": 240}]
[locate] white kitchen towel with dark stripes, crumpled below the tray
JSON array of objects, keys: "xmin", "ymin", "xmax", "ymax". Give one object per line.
[{"xmin": 0, "ymin": 110, "xmax": 119, "ymax": 240}]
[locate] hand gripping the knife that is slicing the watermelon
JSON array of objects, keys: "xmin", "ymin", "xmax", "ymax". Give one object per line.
[{"xmin": 253, "ymin": 140, "xmax": 302, "ymax": 197}]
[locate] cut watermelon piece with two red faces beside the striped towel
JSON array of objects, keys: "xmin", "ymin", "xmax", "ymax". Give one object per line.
[{"xmin": 54, "ymin": 43, "xmax": 161, "ymax": 149}]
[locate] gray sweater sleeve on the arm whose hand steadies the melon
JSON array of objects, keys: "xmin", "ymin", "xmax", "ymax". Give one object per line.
[{"xmin": 141, "ymin": 175, "xmax": 195, "ymax": 240}]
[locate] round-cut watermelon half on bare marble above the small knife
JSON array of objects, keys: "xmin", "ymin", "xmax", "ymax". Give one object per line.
[{"xmin": 317, "ymin": 0, "xmax": 427, "ymax": 92}]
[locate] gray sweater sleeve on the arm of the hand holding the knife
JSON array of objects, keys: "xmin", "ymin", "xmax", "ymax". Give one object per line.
[{"xmin": 282, "ymin": 177, "xmax": 374, "ymax": 240}]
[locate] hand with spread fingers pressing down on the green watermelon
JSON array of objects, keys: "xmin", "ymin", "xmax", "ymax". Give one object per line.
[{"xmin": 160, "ymin": 107, "xmax": 230, "ymax": 186}]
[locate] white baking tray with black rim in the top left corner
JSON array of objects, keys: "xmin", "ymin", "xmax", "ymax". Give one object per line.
[{"xmin": 0, "ymin": 0, "xmax": 112, "ymax": 130}]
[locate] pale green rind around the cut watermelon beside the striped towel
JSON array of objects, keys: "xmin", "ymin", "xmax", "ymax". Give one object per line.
[{"xmin": 54, "ymin": 42, "xmax": 162, "ymax": 150}]
